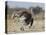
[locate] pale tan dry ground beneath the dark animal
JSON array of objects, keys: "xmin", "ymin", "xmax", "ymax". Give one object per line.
[{"xmin": 7, "ymin": 15, "xmax": 45, "ymax": 33}]
